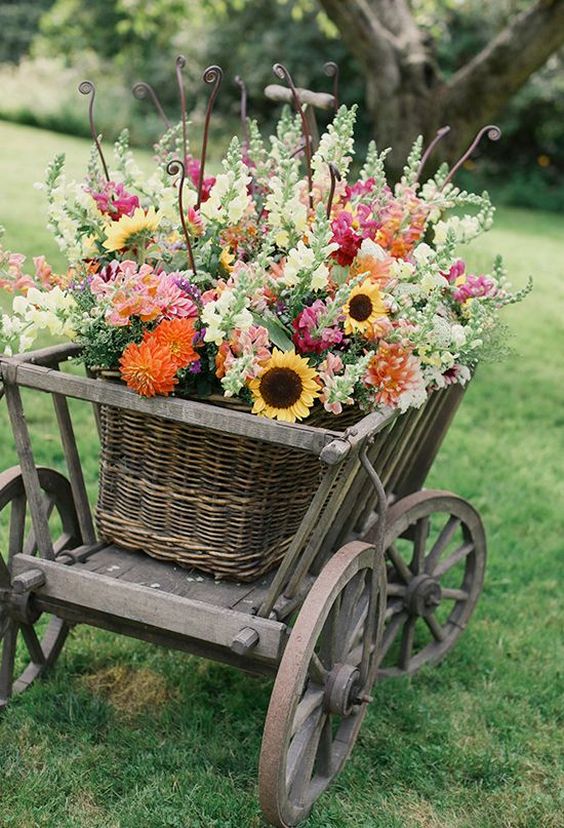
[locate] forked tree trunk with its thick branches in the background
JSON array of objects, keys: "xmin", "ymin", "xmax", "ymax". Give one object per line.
[{"xmin": 320, "ymin": 0, "xmax": 564, "ymax": 177}]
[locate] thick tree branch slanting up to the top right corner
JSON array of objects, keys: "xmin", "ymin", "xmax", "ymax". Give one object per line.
[{"xmin": 443, "ymin": 0, "xmax": 564, "ymax": 125}]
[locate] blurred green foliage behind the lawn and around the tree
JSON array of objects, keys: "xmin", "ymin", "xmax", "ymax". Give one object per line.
[{"xmin": 0, "ymin": 0, "xmax": 564, "ymax": 210}]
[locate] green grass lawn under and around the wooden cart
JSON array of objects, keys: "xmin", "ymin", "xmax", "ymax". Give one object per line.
[{"xmin": 0, "ymin": 118, "xmax": 564, "ymax": 828}]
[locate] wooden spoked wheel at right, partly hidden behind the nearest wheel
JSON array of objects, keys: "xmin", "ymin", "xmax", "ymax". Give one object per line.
[{"xmin": 379, "ymin": 491, "xmax": 486, "ymax": 678}]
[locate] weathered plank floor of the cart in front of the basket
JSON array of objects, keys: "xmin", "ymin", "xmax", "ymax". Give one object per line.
[{"xmin": 73, "ymin": 545, "xmax": 273, "ymax": 613}]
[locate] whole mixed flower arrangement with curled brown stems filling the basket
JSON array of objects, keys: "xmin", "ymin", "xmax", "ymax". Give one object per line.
[{"xmin": 0, "ymin": 64, "xmax": 530, "ymax": 422}]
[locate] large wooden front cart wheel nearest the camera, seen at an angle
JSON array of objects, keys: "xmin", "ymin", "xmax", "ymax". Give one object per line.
[{"xmin": 259, "ymin": 541, "xmax": 386, "ymax": 828}]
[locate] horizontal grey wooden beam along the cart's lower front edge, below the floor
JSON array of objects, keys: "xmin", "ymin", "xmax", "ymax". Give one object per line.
[{"xmin": 14, "ymin": 555, "xmax": 286, "ymax": 660}]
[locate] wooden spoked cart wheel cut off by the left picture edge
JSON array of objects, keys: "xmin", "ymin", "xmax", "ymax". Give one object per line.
[{"xmin": 0, "ymin": 466, "xmax": 80, "ymax": 710}]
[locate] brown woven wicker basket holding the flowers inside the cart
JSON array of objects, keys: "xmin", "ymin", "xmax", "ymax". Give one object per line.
[{"xmin": 96, "ymin": 406, "xmax": 361, "ymax": 581}]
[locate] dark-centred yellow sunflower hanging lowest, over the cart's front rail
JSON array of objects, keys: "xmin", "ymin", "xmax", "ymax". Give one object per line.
[{"xmin": 249, "ymin": 348, "xmax": 319, "ymax": 423}]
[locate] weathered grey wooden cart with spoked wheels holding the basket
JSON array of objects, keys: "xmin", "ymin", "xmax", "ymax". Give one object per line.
[{"xmin": 0, "ymin": 345, "xmax": 486, "ymax": 826}]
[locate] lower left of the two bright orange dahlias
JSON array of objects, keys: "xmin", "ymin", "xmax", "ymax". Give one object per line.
[{"xmin": 119, "ymin": 339, "xmax": 178, "ymax": 397}]
